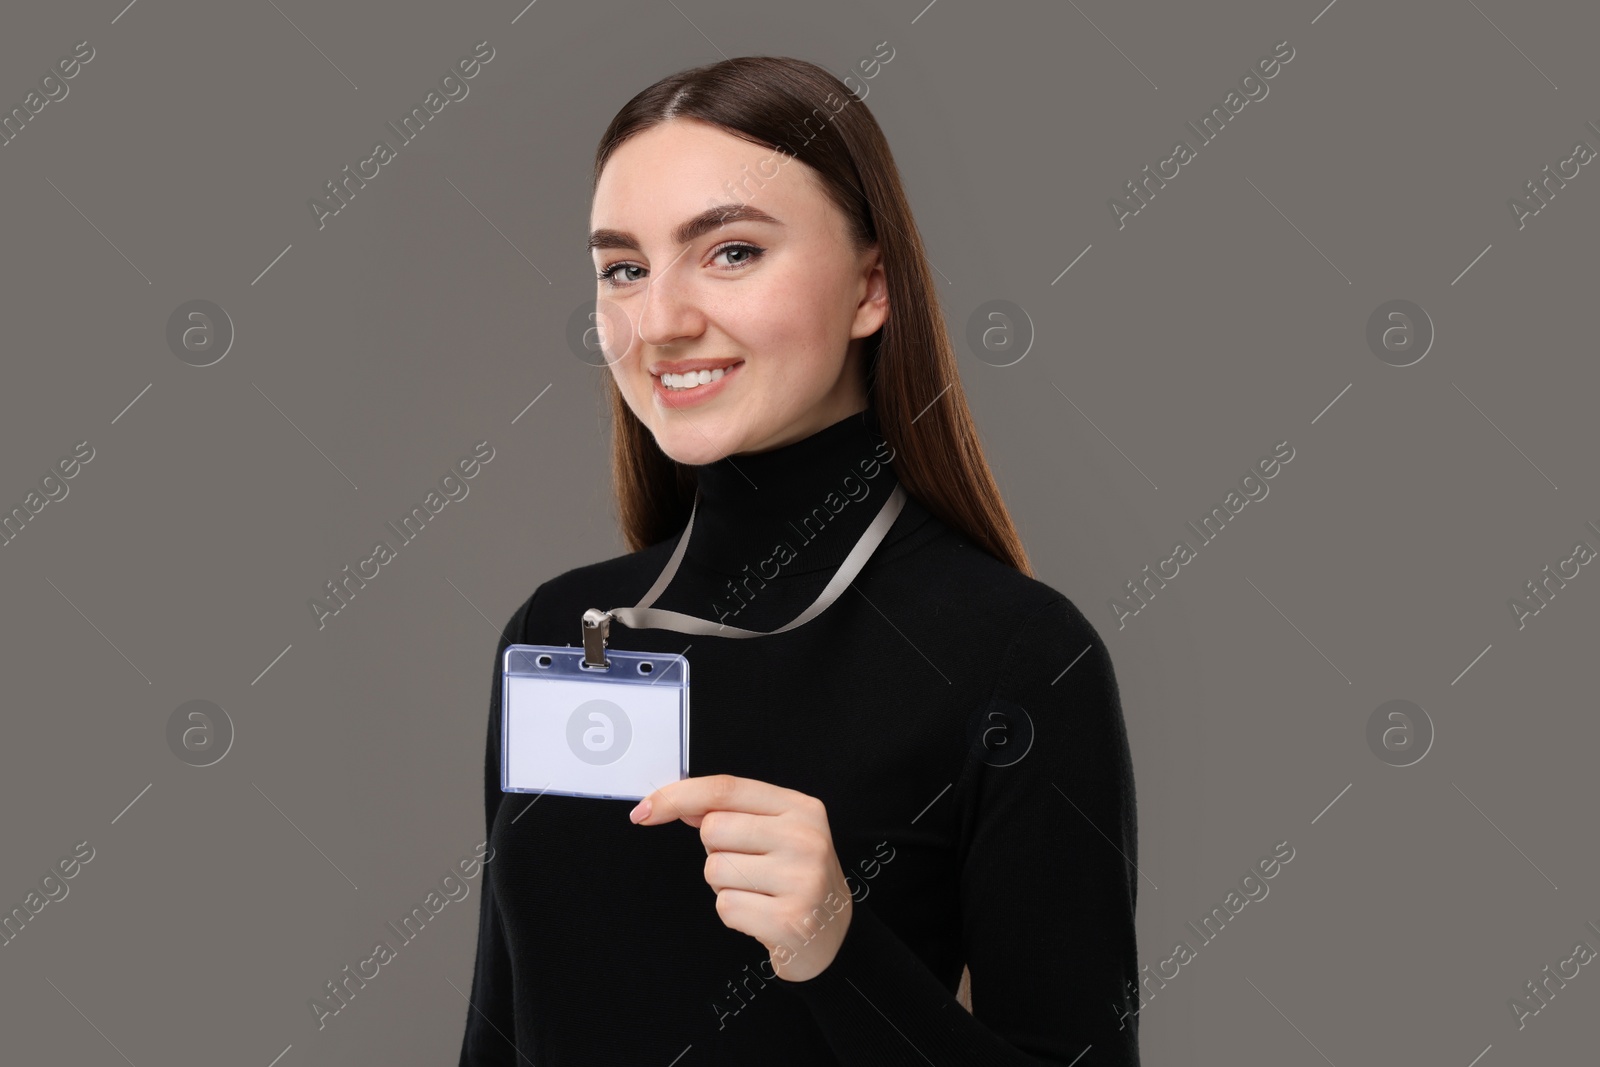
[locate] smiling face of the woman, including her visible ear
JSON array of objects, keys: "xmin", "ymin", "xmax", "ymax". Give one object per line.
[{"xmin": 590, "ymin": 118, "xmax": 888, "ymax": 466}]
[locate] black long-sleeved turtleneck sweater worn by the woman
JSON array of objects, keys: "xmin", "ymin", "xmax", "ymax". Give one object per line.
[{"xmin": 461, "ymin": 410, "xmax": 1139, "ymax": 1067}]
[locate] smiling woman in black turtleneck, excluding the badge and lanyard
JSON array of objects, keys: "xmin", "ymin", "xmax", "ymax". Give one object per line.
[{"xmin": 461, "ymin": 58, "xmax": 1138, "ymax": 1067}]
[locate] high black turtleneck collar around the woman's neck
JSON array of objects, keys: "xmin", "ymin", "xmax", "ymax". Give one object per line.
[{"xmin": 683, "ymin": 406, "xmax": 898, "ymax": 577}]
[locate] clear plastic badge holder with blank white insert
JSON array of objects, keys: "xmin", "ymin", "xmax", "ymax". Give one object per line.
[{"xmin": 501, "ymin": 645, "xmax": 690, "ymax": 800}]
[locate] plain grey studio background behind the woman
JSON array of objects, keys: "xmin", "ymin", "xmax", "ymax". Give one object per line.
[{"xmin": 0, "ymin": 0, "xmax": 1600, "ymax": 1067}]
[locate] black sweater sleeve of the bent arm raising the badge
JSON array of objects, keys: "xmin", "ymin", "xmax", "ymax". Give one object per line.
[{"xmin": 790, "ymin": 597, "xmax": 1141, "ymax": 1067}]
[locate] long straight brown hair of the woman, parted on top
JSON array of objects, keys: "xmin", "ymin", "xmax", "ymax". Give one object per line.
[{"xmin": 590, "ymin": 56, "xmax": 1034, "ymax": 577}]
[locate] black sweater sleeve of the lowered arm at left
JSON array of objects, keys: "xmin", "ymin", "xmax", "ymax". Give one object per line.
[{"xmin": 459, "ymin": 592, "xmax": 539, "ymax": 1067}]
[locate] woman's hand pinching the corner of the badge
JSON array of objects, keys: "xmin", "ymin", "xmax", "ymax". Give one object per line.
[{"xmin": 629, "ymin": 774, "xmax": 853, "ymax": 982}]
